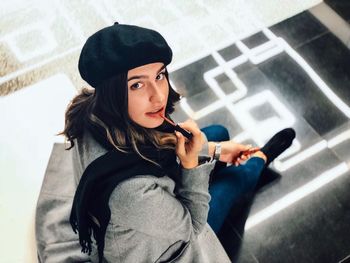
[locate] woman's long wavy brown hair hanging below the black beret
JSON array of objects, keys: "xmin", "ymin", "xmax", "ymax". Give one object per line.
[{"xmin": 58, "ymin": 71, "xmax": 181, "ymax": 163}]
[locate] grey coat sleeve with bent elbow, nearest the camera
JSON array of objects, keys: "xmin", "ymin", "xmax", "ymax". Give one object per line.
[{"xmin": 109, "ymin": 162, "xmax": 215, "ymax": 238}]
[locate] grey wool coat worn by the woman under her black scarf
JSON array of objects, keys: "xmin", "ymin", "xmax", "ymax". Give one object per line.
[{"xmin": 36, "ymin": 133, "xmax": 230, "ymax": 263}]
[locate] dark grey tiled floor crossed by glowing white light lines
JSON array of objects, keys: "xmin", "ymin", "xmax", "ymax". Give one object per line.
[{"xmin": 171, "ymin": 8, "xmax": 350, "ymax": 263}]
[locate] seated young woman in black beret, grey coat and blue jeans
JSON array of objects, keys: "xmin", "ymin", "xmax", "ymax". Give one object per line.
[{"xmin": 62, "ymin": 23, "xmax": 295, "ymax": 262}]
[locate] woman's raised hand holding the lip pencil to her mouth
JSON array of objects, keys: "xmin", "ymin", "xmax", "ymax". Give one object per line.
[{"xmin": 175, "ymin": 119, "xmax": 204, "ymax": 169}]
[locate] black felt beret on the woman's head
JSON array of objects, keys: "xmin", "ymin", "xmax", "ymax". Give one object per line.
[{"xmin": 78, "ymin": 22, "xmax": 173, "ymax": 88}]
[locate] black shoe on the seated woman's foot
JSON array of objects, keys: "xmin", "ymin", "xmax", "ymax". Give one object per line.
[{"xmin": 260, "ymin": 128, "xmax": 295, "ymax": 167}]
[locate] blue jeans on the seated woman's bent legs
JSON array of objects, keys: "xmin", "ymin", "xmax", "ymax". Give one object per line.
[{"xmin": 201, "ymin": 125, "xmax": 265, "ymax": 233}]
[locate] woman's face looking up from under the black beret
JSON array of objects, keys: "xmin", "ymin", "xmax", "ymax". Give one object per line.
[{"xmin": 128, "ymin": 62, "xmax": 169, "ymax": 128}]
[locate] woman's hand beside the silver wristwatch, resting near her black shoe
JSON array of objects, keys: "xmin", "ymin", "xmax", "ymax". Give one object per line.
[{"xmin": 219, "ymin": 141, "xmax": 259, "ymax": 166}]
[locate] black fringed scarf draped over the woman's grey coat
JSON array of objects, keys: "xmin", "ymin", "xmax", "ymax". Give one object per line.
[{"xmin": 70, "ymin": 120, "xmax": 179, "ymax": 262}]
